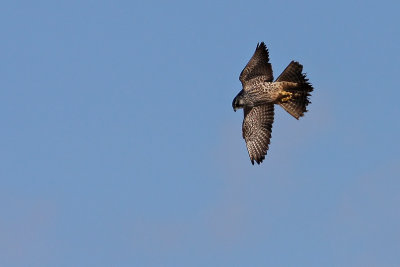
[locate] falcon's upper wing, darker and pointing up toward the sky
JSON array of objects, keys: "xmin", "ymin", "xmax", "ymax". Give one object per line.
[{"xmin": 239, "ymin": 42, "xmax": 274, "ymax": 87}]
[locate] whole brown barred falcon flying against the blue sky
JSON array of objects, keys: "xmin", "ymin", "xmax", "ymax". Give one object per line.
[{"xmin": 232, "ymin": 42, "xmax": 313, "ymax": 165}]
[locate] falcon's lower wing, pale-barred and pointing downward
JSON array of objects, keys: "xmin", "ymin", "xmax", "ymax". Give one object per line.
[{"xmin": 242, "ymin": 104, "xmax": 274, "ymax": 165}]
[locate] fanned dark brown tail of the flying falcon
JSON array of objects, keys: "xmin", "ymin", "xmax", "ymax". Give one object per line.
[{"xmin": 276, "ymin": 61, "xmax": 314, "ymax": 119}]
